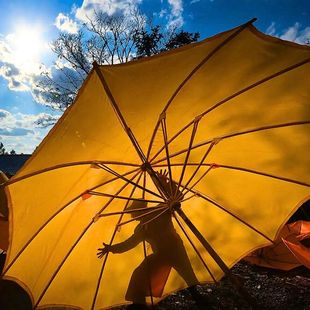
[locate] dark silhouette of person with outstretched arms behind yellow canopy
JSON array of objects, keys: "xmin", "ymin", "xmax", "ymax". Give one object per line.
[{"xmin": 97, "ymin": 173, "xmax": 199, "ymax": 309}]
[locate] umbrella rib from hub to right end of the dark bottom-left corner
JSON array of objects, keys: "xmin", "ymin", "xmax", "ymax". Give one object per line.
[{"xmin": 34, "ymin": 171, "xmax": 141, "ymax": 308}]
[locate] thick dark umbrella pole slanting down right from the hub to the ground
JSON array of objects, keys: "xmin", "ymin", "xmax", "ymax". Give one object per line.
[{"xmin": 175, "ymin": 208, "xmax": 258, "ymax": 309}]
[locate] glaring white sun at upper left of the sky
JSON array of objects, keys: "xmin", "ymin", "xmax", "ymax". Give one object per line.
[{"xmin": 8, "ymin": 25, "xmax": 47, "ymax": 72}]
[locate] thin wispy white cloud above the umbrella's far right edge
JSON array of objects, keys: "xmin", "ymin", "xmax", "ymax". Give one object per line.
[{"xmin": 266, "ymin": 22, "xmax": 310, "ymax": 44}]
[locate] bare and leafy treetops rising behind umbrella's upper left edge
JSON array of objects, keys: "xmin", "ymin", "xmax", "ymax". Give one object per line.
[{"xmin": 34, "ymin": 11, "xmax": 199, "ymax": 114}]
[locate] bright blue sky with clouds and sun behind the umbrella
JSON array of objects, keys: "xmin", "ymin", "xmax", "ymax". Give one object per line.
[{"xmin": 0, "ymin": 0, "xmax": 310, "ymax": 153}]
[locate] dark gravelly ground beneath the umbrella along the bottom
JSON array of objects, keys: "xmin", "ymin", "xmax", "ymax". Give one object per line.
[{"xmin": 0, "ymin": 262, "xmax": 310, "ymax": 310}]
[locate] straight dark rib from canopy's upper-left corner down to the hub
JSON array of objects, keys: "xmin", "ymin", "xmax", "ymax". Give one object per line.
[{"xmin": 93, "ymin": 62, "xmax": 146, "ymax": 162}]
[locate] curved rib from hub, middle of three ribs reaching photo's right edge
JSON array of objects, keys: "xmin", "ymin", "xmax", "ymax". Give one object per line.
[{"xmin": 153, "ymin": 120, "xmax": 310, "ymax": 165}]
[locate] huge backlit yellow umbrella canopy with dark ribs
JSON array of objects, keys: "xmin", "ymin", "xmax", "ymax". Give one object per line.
[{"xmin": 4, "ymin": 22, "xmax": 310, "ymax": 309}]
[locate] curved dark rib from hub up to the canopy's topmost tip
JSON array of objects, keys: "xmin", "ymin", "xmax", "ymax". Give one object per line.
[{"xmin": 147, "ymin": 18, "xmax": 256, "ymax": 158}]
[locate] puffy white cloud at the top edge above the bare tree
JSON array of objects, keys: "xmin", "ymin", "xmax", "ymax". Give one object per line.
[{"xmin": 75, "ymin": 0, "xmax": 142, "ymax": 22}]
